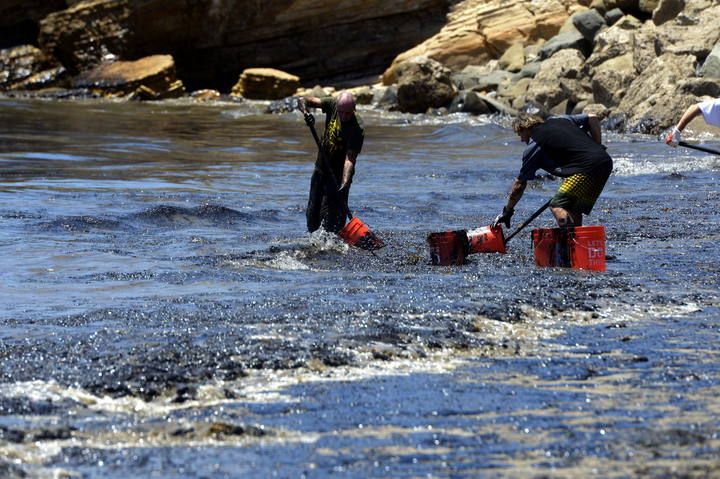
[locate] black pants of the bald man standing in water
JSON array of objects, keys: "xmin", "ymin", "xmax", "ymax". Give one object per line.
[{"xmin": 305, "ymin": 169, "xmax": 350, "ymax": 233}]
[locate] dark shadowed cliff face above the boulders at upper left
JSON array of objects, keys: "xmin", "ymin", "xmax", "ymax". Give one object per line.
[{"xmin": 32, "ymin": 0, "xmax": 451, "ymax": 91}]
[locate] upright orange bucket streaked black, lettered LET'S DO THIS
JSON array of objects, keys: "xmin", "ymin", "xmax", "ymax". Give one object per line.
[{"xmin": 532, "ymin": 226, "xmax": 605, "ymax": 271}]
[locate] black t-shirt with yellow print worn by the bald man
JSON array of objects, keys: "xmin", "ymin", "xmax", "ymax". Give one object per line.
[{"xmin": 315, "ymin": 97, "xmax": 365, "ymax": 181}]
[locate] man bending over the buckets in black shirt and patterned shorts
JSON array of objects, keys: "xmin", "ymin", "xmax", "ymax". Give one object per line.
[{"xmin": 493, "ymin": 115, "xmax": 612, "ymax": 228}]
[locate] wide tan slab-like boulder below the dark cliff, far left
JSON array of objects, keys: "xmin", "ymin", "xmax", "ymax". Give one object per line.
[{"xmin": 74, "ymin": 55, "xmax": 184, "ymax": 99}]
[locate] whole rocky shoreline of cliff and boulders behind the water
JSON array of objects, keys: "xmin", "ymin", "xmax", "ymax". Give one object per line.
[{"xmin": 0, "ymin": 0, "xmax": 720, "ymax": 134}]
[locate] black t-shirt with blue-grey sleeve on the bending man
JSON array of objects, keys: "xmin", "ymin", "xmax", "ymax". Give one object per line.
[{"xmin": 518, "ymin": 117, "xmax": 612, "ymax": 181}]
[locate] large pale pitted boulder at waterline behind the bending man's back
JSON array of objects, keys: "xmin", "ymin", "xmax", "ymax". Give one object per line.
[{"xmin": 618, "ymin": 53, "xmax": 697, "ymax": 134}]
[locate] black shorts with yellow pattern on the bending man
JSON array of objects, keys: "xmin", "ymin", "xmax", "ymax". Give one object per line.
[{"xmin": 550, "ymin": 163, "xmax": 612, "ymax": 215}]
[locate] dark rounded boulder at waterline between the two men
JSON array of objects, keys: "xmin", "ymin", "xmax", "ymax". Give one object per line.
[{"xmin": 397, "ymin": 57, "xmax": 457, "ymax": 113}]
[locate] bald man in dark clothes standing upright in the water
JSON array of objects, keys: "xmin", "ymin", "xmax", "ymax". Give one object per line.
[{"xmin": 300, "ymin": 92, "xmax": 365, "ymax": 233}]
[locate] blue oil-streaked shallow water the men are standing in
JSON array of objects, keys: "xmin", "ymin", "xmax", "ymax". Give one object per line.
[{"xmin": 0, "ymin": 100, "xmax": 720, "ymax": 477}]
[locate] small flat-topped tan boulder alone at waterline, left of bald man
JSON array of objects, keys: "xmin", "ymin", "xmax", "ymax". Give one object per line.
[{"xmin": 231, "ymin": 68, "xmax": 300, "ymax": 100}]
